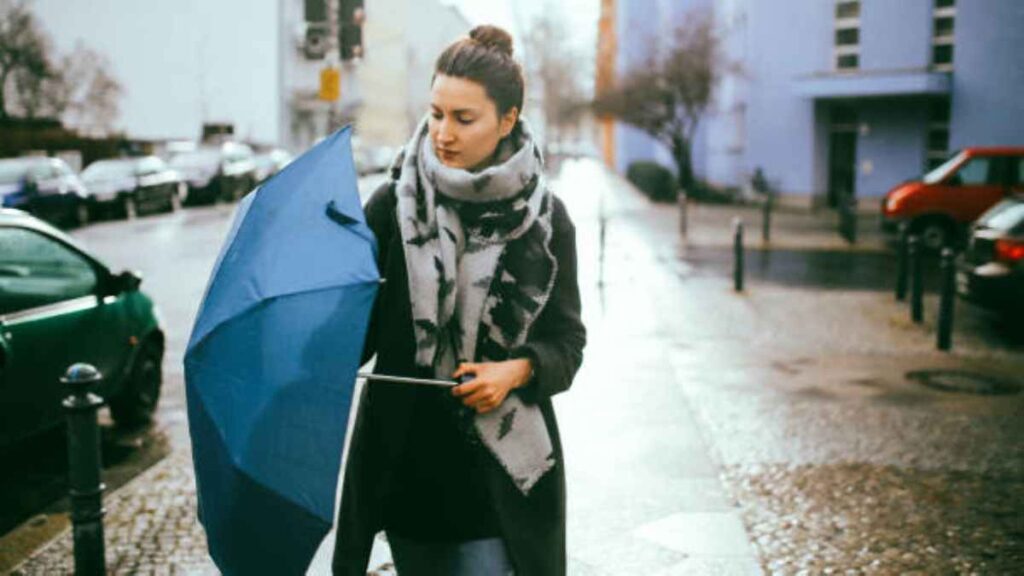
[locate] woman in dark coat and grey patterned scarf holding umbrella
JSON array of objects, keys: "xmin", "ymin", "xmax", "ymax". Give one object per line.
[{"xmin": 334, "ymin": 27, "xmax": 586, "ymax": 576}]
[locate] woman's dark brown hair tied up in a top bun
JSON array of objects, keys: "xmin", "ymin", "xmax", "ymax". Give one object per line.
[{"xmin": 430, "ymin": 26, "xmax": 524, "ymax": 117}]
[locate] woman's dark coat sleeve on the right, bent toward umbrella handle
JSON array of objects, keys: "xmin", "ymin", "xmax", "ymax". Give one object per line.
[{"xmin": 511, "ymin": 198, "xmax": 587, "ymax": 402}]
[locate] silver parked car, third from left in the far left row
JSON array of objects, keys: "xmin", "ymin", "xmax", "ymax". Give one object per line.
[{"xmin": 170, "ymin": 142, "xmax": 256, "ymax": 204}]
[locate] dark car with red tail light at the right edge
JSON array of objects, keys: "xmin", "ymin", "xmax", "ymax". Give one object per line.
[{"xmin": 956, "ymin": 196, "xmax": 1024, "ymax": 313}]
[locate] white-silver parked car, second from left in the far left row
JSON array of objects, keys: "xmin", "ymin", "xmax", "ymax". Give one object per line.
[{"xmin": 82, "ymin": 156, "xmax": 187, "ymax": 218}]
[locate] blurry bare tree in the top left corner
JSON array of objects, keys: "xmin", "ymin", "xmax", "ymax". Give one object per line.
[{"xmin": 0, "ymin": 0, "xmax": 53, "ymax": 120}]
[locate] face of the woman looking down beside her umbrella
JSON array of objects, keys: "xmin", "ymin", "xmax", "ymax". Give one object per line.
[{"xmin": 428, "ymin": 74, "xmax": 518, "ymax": 170}]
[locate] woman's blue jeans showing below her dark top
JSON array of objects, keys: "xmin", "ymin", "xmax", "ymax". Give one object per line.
[{"xmin": 387, "ymin": 534, "xmax": 515, "ymax": 576}]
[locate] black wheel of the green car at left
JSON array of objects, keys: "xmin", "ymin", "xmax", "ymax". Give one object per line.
[{"xmin": 110, "ymin": 340, "xmax": 164, "ymax": 426}]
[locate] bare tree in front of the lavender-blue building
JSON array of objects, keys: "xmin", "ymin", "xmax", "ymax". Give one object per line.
[{"xmin": 594, "ymin": 10, "xmax": 726, "ymax": 192}]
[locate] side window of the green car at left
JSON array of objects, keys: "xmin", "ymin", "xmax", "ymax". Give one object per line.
[{"xmin": 0, "ymin": 228, "xmax": 97, "ymax": 314}]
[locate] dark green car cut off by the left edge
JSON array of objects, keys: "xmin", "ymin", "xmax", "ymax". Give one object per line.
[{"xmin": 0, "ymin": 209, "xmax": 164, "ymax": 446}]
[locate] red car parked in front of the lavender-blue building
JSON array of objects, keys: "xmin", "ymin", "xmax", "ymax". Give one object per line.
[{"xmin": 882, "ymin": 148, "xmax": 1024, "ymax": 250}]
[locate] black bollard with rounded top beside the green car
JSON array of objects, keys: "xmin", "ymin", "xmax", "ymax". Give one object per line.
[{"xmin": 60, "ymin": 364, "xmax": 106, "ymax": 576}]
